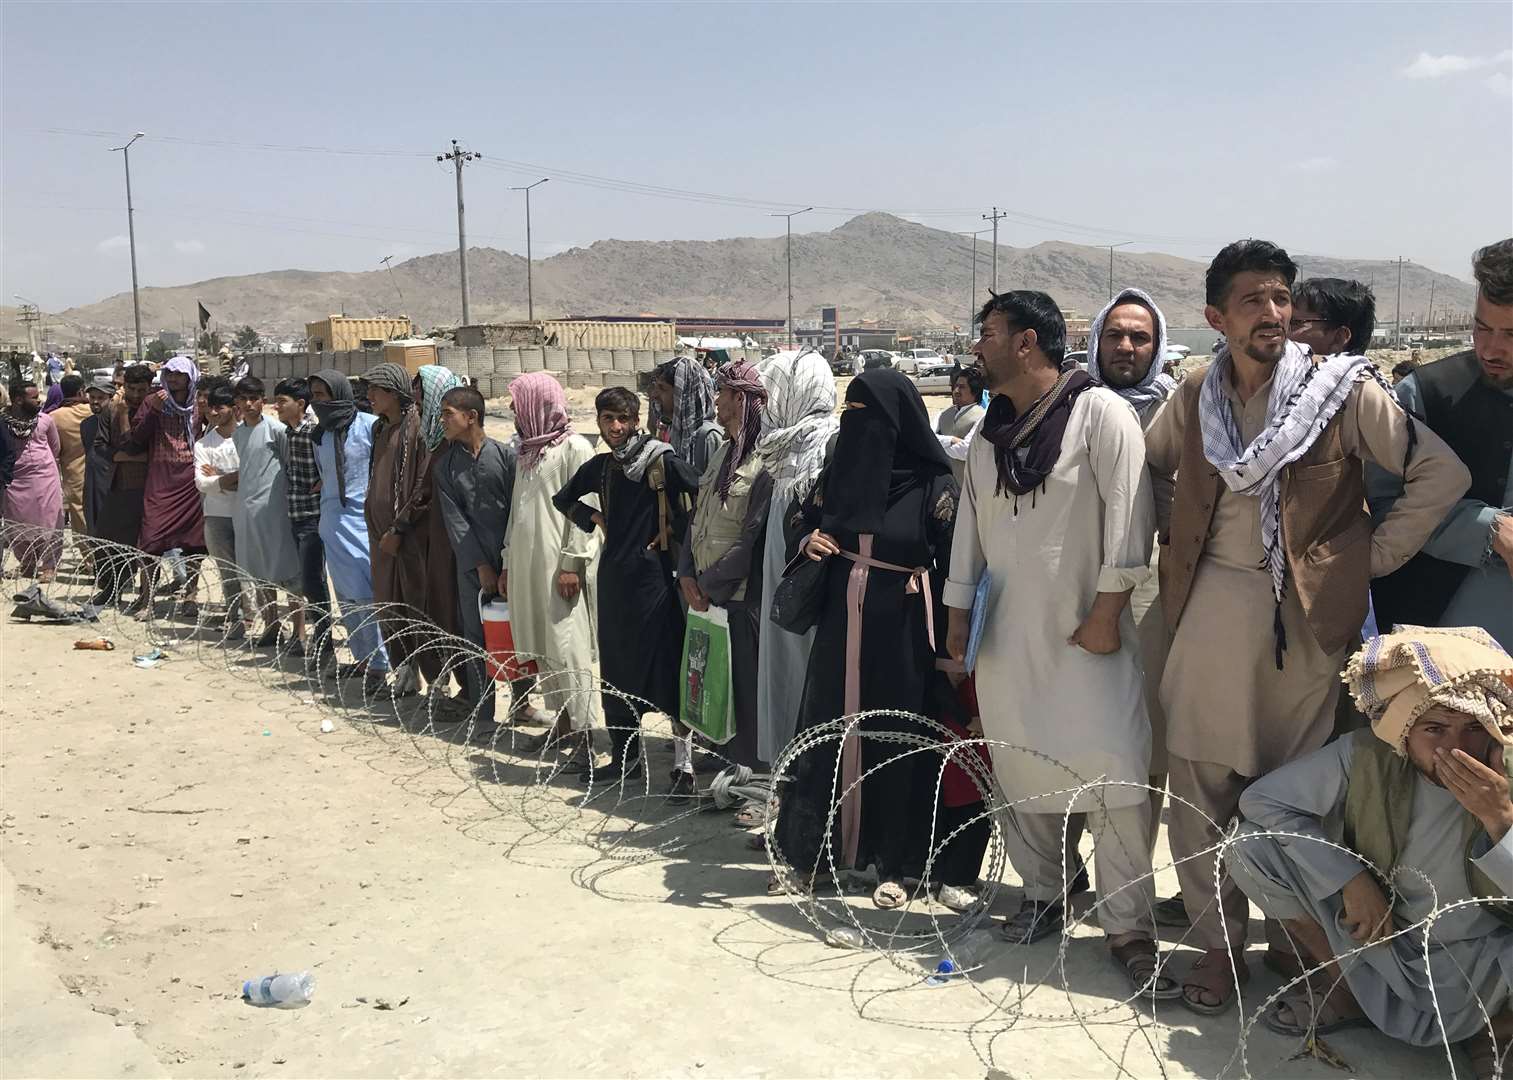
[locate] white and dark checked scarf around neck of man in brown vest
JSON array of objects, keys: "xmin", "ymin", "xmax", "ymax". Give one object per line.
[{"xmin": 1198, "ymin": 335, "xmax": 1395, "ymax": 604}]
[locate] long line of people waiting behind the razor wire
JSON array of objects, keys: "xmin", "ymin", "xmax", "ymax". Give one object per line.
[{"xmin": 0, "ymin": 239, "xmax": 1513, "ymax": 1075}]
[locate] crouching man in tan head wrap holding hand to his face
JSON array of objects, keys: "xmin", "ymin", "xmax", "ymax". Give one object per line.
[{"xmin": 1229, "ymin": 626, "xmax": 1513, "ymax": 1077}]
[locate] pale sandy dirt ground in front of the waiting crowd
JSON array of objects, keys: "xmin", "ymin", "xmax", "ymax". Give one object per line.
[{"xmin": 0, "ymin": 589, "xmax": 1445, "ymax": 1078}]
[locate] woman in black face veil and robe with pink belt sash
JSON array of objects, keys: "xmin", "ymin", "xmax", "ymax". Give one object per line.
[{"xmin": 775, "ymin": 369, "xmax": 956, "ymax": 908}]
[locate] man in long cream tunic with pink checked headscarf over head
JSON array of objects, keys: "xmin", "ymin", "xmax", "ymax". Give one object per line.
[{"xmin": 501, "ymin": 372, "xmax": 604, "ymax": 749}]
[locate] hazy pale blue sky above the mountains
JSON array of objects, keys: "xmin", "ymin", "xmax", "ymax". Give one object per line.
[{"xmin": 0, "ymin": 0, "xmax": 1513, "ymax": 309}]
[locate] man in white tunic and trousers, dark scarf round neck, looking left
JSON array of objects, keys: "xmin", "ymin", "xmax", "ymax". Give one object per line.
[{"xmin": 944, "ymin": 290, "xmax": 1180, "ymax": 998}]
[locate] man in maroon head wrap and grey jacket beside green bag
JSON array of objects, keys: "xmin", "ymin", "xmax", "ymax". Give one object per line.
[{"xmin": 673, "ymin": 360, "xmax": 772, "ymax": 794}]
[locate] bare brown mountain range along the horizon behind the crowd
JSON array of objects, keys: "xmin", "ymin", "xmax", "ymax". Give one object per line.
[{"xmin": 59, "ymin": 213, "xmax": 1475, "ymax": 339}]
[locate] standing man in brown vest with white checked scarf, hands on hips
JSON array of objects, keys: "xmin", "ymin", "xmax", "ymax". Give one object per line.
[{"xmin": 1145, "ymin": 241, "xmax": 1469, "ymax": 1013}]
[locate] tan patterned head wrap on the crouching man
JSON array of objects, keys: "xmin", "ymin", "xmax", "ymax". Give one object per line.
[{"xmin": 1344, "ymin": 626, "xmax": 1513, "ymax": 755}]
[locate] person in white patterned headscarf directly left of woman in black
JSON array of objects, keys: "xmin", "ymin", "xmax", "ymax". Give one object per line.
[{"xmin": 757, "ymin": 352, "xmax": 840, "ymax": 761}]
